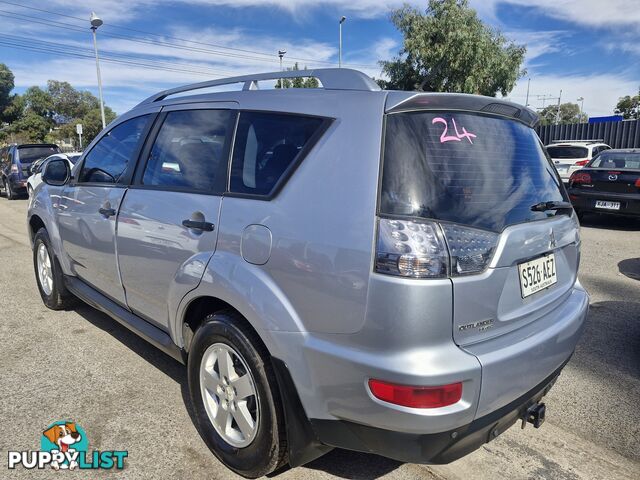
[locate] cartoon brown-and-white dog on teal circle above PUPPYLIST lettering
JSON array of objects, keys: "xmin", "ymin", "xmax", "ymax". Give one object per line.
[{"xmin": 40, "ymin": 421, "xmax": 88, "ymax": 470}]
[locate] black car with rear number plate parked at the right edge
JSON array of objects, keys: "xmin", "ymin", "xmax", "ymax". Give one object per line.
[{"xmin": 569, "ymin": 149, "xmax": 640, "ymax": 217}]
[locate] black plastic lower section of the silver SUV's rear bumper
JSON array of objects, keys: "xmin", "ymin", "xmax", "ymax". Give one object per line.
[{"xmin": 311, "ymin": 360, "xmax": 568, "ymax": 464}]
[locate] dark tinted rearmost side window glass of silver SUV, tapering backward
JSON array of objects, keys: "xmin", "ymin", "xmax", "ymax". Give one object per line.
[{"xmin": 230, "ymin": 112, "xmax": 324, "ymax": 195}]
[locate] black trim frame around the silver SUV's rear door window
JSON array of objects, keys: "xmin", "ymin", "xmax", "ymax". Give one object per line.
[{"xmin": 129, "ymin": 108, "xmax": 239, "ymax": 197}]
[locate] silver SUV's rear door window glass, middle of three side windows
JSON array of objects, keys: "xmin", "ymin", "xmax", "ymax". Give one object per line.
[{"xmin": 142, "ymin": 110, "xmax": 235, "ymax": 193}]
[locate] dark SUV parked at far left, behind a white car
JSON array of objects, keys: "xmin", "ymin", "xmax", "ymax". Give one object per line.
[{"xmin": 0, "ymin": 143, "xmax": 60, "ymax": 200}]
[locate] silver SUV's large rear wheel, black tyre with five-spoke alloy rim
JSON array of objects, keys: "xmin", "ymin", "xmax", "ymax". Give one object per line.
[{"xmin": 187, "ymin": 311, "xmax": 288, "ymax": 478}]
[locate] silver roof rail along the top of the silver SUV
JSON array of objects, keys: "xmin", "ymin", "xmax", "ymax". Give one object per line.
[{"xmin": 139, "ymin": 68, "xmax": 380, "ymax": 105}]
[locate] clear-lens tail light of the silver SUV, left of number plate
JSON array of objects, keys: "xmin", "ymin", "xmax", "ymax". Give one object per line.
[{"xmin": 375, "ymin": 218, "xmax": 499, "ymax": 278}]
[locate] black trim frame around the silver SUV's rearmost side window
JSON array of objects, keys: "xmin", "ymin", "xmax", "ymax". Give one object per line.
[{"xmin": 225, "ymin": 109, "xmax": 335, "ymax": 201}]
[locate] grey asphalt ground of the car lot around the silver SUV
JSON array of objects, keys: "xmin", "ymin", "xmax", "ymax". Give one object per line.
[{"xmin": 0, "ymin": 197, "xmax": 640, "ymax": 480}]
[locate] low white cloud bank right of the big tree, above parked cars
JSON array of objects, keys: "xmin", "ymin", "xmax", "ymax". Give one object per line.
[{"xmin": 508, "ymin": 73, "xmax": 638, "ymax": 117}]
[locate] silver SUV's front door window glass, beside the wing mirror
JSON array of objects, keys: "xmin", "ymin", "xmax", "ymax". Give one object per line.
[{"xmin": 78, "ymin": 115, "xmax": 150, "ymax": 183}]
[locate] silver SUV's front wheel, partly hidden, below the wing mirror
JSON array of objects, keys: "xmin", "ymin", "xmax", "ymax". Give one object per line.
[{"xmin": 33, "ymin": 228, "xmax": 77, "ymax": 310}]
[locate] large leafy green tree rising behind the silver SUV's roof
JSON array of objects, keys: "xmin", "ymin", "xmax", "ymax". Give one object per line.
[{"xmin": 379, "ymin": 0, "xmax": 526, "ymax": 96}]
